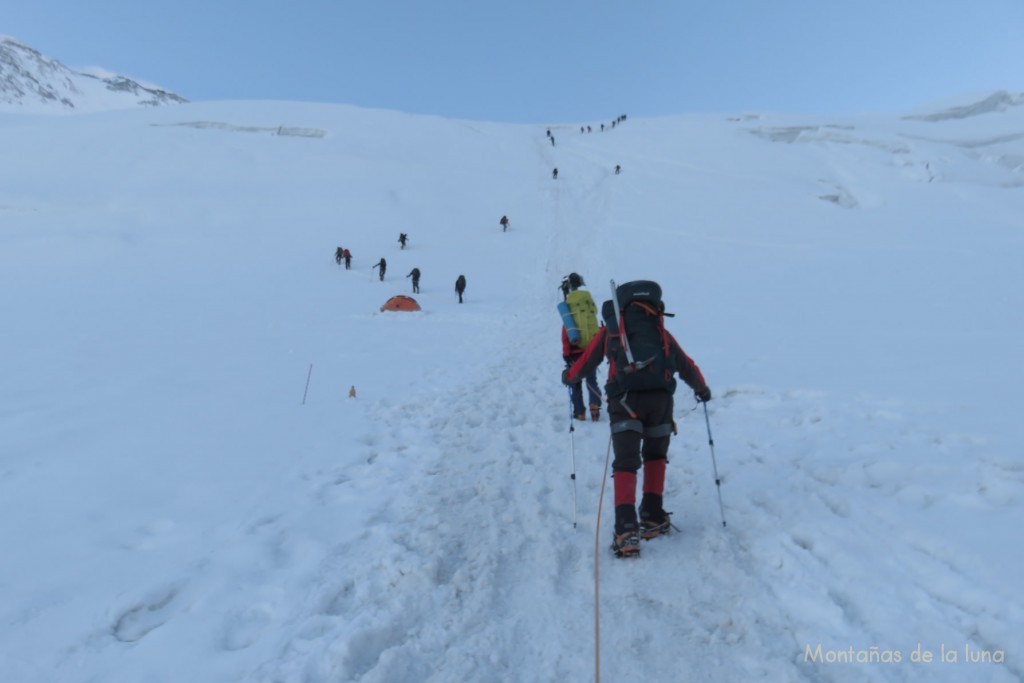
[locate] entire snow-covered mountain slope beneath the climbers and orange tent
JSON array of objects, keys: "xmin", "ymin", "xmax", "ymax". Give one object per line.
[{"xmin": 0, "ymin": 97, "xmax": 1024, "ymax": 683}]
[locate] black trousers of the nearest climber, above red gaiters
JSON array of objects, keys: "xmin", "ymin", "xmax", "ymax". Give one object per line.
[{"xmin": 607, "ymin": 389, "xmax": 674, "ymax": 472}]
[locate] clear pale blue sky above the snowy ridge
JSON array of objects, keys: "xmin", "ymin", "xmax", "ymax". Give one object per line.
[{"xmin": 8, "ymin": 0, "xmax": 1024, "ymax": 123}]
